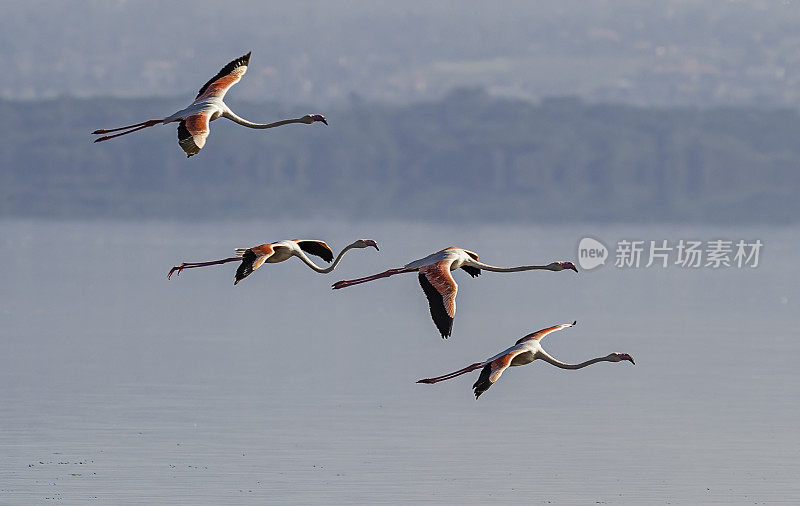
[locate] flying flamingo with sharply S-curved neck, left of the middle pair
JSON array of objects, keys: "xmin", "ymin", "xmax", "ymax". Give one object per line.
[{"xmin": 167, "ymin": 239, "xmax": 378, "ymax": 285}]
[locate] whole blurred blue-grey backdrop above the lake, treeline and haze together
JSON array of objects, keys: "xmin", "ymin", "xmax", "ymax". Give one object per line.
[{"xmin": 0, "ymin": 0, "xmax": 800, "ymax": 224}]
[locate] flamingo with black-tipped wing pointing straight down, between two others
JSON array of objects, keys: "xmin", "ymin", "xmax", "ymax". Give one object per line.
[{"xmin": 333, "ymin": 247, "xmax": 578, "ymax": 339}]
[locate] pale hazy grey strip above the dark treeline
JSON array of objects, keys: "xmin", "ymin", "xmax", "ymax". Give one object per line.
[{"xmin": 0, "ymin": 0, "xmax": 800, "ymax": 106}]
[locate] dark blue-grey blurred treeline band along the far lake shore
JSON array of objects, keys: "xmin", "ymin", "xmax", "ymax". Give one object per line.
[{"xmin": 0, "ymin": 90, "xmax": 800, "ymax": 223}]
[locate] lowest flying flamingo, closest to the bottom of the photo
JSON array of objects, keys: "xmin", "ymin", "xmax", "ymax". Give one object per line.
[{"xmin": 417, "ymin": 321, "xmax": 636, "ymax": 400}]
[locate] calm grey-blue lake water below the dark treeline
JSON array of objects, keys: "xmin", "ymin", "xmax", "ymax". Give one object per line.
[{"xmin": 0, "ymin": 220, "xmax": 800, "ymax": 504}]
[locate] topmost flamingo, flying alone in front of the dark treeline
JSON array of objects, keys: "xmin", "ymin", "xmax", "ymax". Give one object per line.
[{"xmin": 92, "ymin": 53, "xmax": 328, "ymax": 158}]
